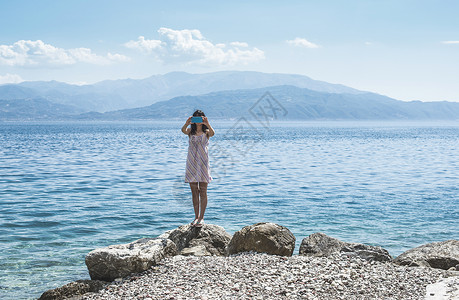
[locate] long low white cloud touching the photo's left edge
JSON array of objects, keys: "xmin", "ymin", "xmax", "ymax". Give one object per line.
[{"xmin": 0, "ymin": 40, "xmax": 129, "ymax": 66}]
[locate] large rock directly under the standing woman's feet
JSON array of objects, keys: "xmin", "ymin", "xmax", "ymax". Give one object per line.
[{"xmin": 159, "ymin": 224, "xmax": 231, "ymax": 256}]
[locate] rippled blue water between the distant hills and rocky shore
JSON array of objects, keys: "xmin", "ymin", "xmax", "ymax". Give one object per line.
[{"xmin": 0, "ymin": 122, "xmax": 459, "ymax": 299}]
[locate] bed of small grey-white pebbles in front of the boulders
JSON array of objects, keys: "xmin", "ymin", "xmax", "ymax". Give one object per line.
[{"xmin": 80, "ymin": 252, "xmax": 446, "ymax": 300}]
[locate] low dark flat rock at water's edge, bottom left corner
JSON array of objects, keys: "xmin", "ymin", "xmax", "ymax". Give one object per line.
[{"xmin": 39, "ymin": 280, "xmax": 108, "ymax": 300}]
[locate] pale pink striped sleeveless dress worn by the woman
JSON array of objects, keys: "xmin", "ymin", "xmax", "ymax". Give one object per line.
[{"xmin": 185, "ymin": 133, "xmax": 212, "ymax": 183}]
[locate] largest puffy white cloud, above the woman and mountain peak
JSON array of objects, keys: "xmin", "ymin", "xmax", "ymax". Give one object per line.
[{"xmin": 124, "ymin": 27, "xmax": 265, "ymax": 65}]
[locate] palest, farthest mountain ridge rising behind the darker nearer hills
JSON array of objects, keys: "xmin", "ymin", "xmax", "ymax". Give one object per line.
[{"xmin": 0, "ymin": 71, "xmax": 362, "ymax": 112}]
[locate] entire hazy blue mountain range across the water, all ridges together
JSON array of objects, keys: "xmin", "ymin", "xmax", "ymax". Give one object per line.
[{"xmin": 0, "ymin": 71, "xmax": 459, "ymax": 120}]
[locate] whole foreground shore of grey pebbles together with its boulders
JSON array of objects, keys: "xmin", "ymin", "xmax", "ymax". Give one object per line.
[{"xmin": 40, "ymin": 222, "xmax": 459, "ymax": 300}]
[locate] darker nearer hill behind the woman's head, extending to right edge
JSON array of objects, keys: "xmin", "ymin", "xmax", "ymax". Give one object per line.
[{"xmin": 85, "ymin": 86, "xmax": 459, "ymax": 120}]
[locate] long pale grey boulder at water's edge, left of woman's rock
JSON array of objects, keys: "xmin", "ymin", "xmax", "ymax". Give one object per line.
[{"xmin": 86, "ymin": 238, "xmax": 177, "ymax": 281}]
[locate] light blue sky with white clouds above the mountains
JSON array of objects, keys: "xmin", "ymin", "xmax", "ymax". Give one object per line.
[{"xmin": 0, "ymin": 0, "xmax": 459, "ymax": 102}]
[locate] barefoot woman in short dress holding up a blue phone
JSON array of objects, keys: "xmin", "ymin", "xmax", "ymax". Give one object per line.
[{"xmin": 182, "ymin": 110, "xmax": 215, "ymax": 227}]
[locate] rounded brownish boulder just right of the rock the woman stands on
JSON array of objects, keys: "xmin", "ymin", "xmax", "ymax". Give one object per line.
[{"xmin": 227, "ymin": 223, "xmax": 296, "ymax": 256}]
